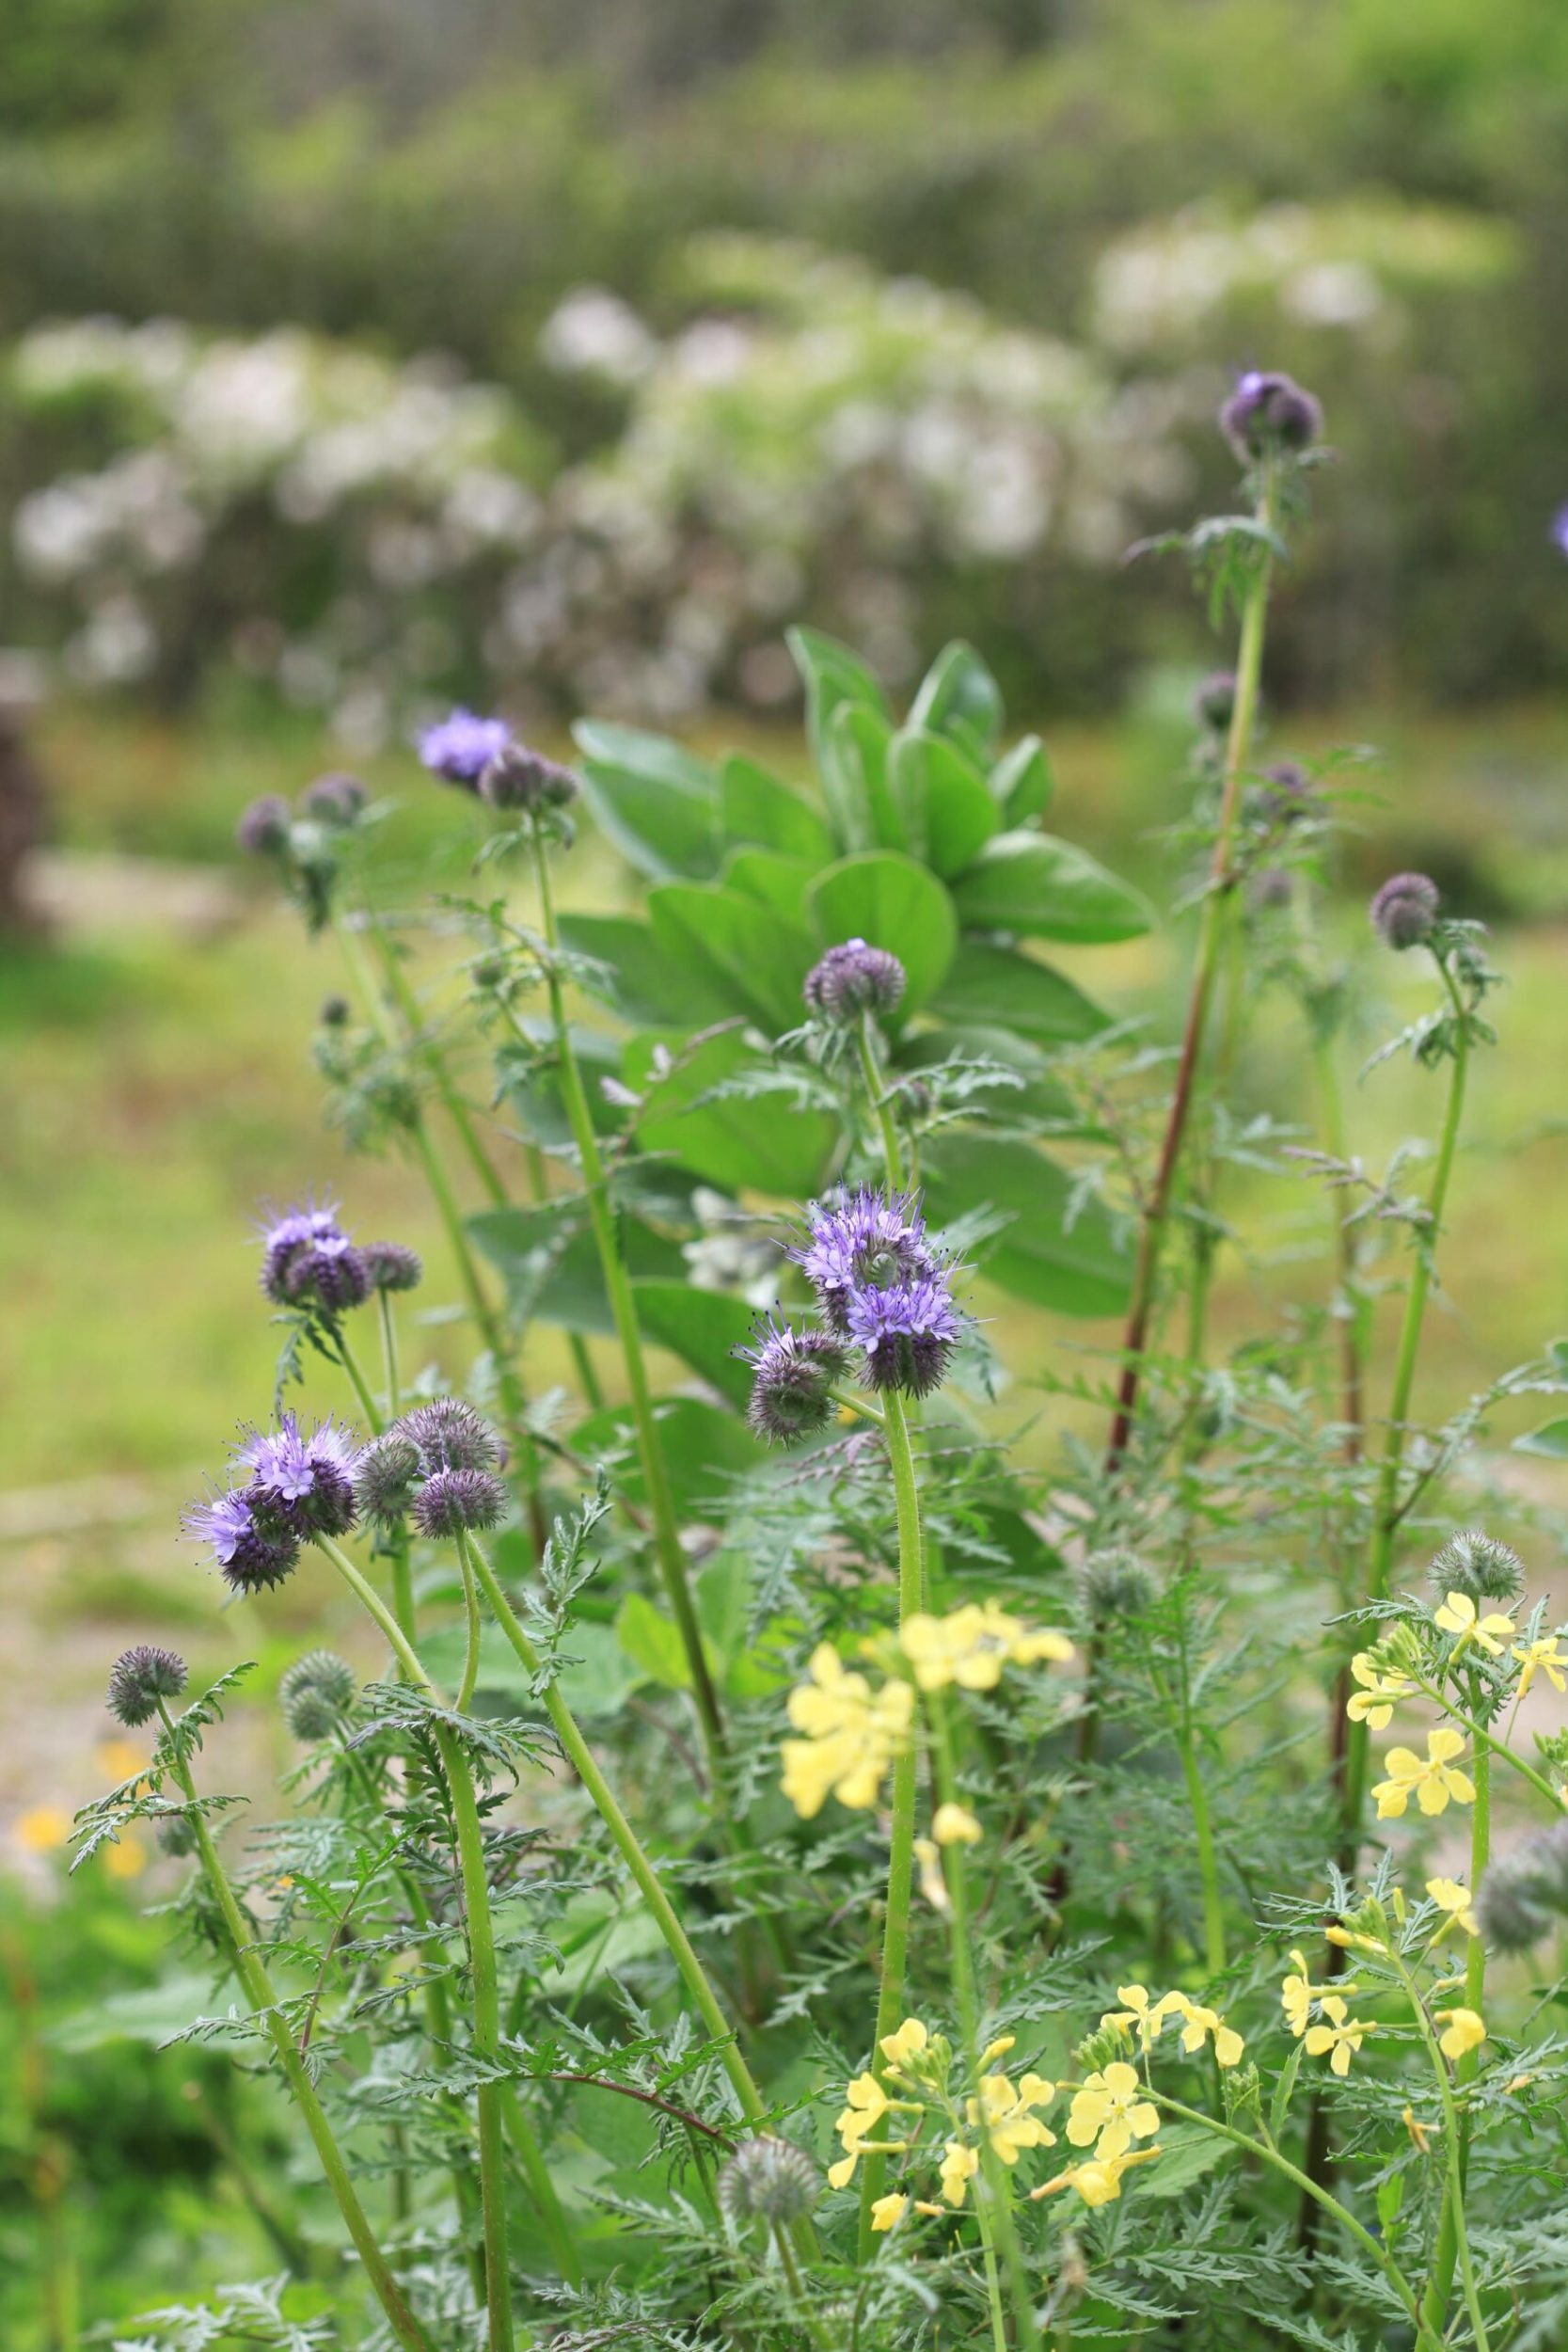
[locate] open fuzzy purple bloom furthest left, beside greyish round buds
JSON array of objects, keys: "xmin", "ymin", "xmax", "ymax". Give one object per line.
[{"xmin": 185, "ymin": 1414, "xmax": 357, "ymax": 1593}]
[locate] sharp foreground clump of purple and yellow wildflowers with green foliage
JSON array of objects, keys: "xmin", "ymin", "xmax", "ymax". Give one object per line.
[{"xmin": 82, "ymin": 372, "xmax": 1568, "ymax": 2352}]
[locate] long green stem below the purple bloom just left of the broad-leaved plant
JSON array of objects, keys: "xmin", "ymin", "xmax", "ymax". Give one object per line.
[{"xmin": 533, "ymin": 833, "xmax": 726, "ymax": 1806}]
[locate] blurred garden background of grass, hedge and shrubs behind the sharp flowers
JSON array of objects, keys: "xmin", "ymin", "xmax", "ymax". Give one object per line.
[{"xmin": 0, "ymin": 0, "xmax": 1568, "ymax": 2352}]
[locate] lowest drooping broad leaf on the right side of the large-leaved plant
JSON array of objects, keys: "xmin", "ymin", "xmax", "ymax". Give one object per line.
[{"xmin": 927, "ymin": 1134, "xmax": 1131, "ymax": 1315}]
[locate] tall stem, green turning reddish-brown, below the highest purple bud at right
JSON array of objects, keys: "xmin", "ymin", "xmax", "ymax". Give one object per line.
[{"xmin": 1105, "ymin": 466, "xmax": 1279, "ymax": 1472}]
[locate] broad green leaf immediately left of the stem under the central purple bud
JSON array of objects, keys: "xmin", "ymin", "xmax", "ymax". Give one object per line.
[{"xmin": 623, "ymin": 1028, "xmax": 837, "ymax": 1200}]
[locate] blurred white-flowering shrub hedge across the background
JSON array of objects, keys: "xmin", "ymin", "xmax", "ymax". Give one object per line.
[{"xmin": 0, "ymin": 218, "xmax": 1507, "ymax": 753}]
